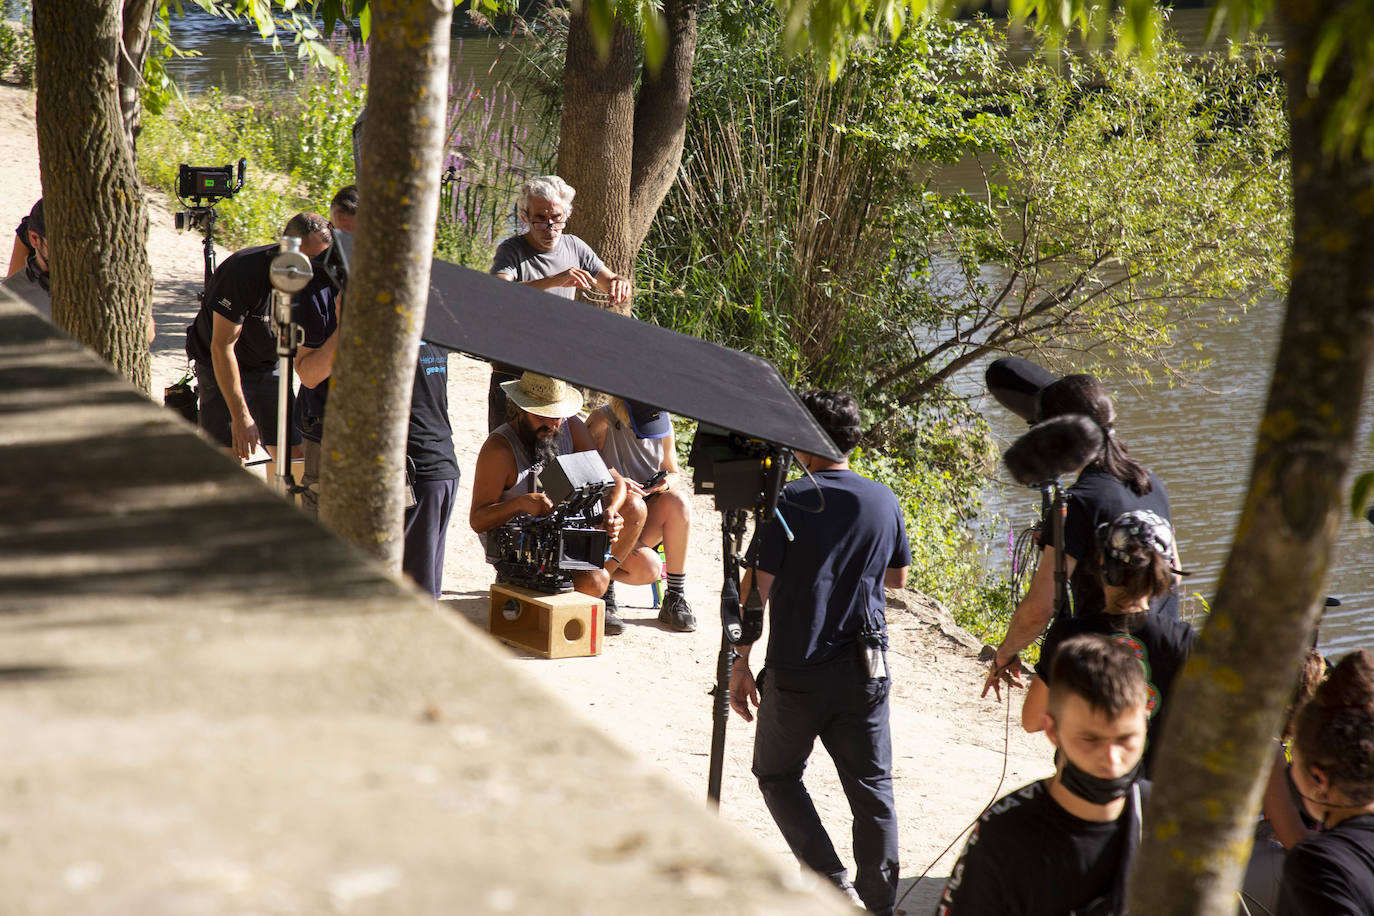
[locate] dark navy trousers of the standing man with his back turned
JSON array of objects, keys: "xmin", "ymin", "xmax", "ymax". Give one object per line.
[{"xmin": 753, "ymin": 651, "xmax": 899, "ymax": 916}]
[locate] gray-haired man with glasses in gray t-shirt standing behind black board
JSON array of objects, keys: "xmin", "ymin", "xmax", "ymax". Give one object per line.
[{"xmin": 486, "ymin": 174, "xmax": 631, "ymax": 430}]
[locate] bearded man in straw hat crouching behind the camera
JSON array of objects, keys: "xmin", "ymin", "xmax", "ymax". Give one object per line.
[{"xmin": 469, "ymin": 372, "xmax": 660, "ymax": 636}]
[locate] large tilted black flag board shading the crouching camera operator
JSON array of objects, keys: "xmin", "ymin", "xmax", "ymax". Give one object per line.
[{"xmin": 425, "ymin": 260, "xmax": 841, "ymax": 460}]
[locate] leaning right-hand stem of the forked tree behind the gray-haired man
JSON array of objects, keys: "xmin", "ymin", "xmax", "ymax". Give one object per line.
[{"xmin": 627, "ymin": 0, "xmax": 697, "ymax": 255}]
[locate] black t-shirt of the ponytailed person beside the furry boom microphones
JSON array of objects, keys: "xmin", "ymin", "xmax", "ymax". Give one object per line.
[{"xmin": 1040, "ymin": 468, "xmax": 1179, "ymax": 617}]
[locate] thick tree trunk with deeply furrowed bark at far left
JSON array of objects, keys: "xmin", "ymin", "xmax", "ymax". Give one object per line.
[{"xmin": 33, "ymin": 0, "xmax": 153, "ymax": 391}]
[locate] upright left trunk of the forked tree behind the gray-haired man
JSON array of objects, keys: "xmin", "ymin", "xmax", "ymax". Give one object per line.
[{"xmin": 558, "ymin": 14, "xmax": 635, "ymax": 312}]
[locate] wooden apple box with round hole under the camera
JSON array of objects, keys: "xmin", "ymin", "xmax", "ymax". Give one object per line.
[{"xmin": 488, "ymin": 584, "xmax": 606, "ymax": 658}]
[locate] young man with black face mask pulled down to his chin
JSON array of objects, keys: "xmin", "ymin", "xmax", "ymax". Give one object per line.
[{"xmin": 936, "ymin": 636, "xmax": 1149, "ymax": 916}]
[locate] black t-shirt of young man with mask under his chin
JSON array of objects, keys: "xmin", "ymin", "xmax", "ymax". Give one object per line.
[{"xmin": 936, "ymin": 780, "xmax": 1150, "ymax": 916}]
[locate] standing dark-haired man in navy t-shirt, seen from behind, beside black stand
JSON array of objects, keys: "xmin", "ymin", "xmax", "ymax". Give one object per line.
[{"xmin": 730, "ymin": 391, "xmax": 911, "ymax": 913}]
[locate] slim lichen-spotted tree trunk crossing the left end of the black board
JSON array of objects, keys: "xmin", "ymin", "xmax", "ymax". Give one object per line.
[{"xmin": 320, "ymin": 0, "xmax": 453, "ymax": 573}]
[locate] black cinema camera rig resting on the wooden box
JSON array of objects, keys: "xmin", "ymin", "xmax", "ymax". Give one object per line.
[{"xmin": 486, "ymin": 452, "xmax": 614, "ymax": 593}]
